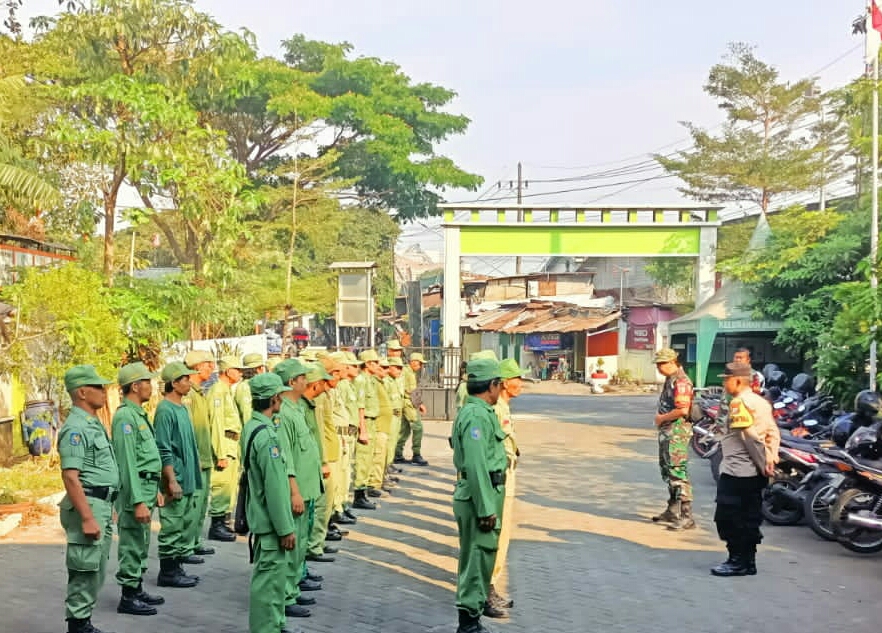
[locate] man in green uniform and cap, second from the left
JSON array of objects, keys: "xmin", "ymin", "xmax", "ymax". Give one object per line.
[{"xmin": 111, "ymin": 363, "xmax": 165, "ymax": 615}]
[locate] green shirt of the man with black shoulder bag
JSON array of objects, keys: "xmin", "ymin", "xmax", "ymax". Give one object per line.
[{"xmin": 239, "ymin": 411, "xmax": 295, "ymax": 536}]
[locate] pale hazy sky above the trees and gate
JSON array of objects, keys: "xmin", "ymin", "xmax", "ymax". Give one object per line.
[{"xmin": 20, "ymin": 0, "xmax": 865, "ymax": 262}]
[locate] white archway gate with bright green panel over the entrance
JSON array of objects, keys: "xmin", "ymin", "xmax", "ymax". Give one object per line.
[{"xmin": 440, "ymin": 204, "xmax": 720, "ymax": 347}]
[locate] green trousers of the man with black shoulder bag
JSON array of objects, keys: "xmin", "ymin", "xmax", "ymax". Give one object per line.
[{"xmin": 248, "ymin": 534, "xmax": 292, "ymax": 633}]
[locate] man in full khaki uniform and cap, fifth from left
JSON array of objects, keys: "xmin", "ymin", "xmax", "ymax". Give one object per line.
[{"xmin": 206, "ymin": 356, "xmax": 242, "ymax": 541}]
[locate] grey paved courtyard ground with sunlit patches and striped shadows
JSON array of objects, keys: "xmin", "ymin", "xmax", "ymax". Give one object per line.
[{"xmin": 0, "ymin": 395, "xmax": 882, "ymax": 633}]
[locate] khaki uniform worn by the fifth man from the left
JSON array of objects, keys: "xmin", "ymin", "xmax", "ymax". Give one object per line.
[{"xmin": 206, "ymin": 380, "xmax": 242, "ymax": 517}]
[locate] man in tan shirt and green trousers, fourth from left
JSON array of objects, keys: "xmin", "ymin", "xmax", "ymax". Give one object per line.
[{"xmin": 183, "ymin": 350, "xmax": 217, "ymax": 556}]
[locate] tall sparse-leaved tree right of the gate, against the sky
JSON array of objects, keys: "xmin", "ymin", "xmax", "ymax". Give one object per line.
[{"xmin": 655, "ymin": 44, "xmax": 840, "ymax": 214}]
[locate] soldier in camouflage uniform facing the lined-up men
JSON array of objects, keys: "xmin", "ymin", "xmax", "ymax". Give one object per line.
[{"xmin": 652, "ymin": 349, "xmax": 695, "ymax": 530}]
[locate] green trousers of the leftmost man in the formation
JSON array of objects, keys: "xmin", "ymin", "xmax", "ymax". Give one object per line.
[{"xmin": 59, "ymin": 497, "xmax": 113, "ymax": 620}]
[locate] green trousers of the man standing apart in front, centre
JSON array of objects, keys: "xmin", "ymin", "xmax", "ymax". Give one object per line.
[{"xmin": 453, "ymin": 491, "xmax": 504, "ymax": 618}]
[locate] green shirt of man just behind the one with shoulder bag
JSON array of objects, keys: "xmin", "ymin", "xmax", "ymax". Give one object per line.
[{"xmin": 278, "ymin": 397, "xmax": 322, "ymax": 501}]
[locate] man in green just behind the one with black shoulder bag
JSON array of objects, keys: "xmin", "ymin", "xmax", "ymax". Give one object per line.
[{"xmin": 273, "ymin": 358, "xmax": 322, "ymax": 617}]
